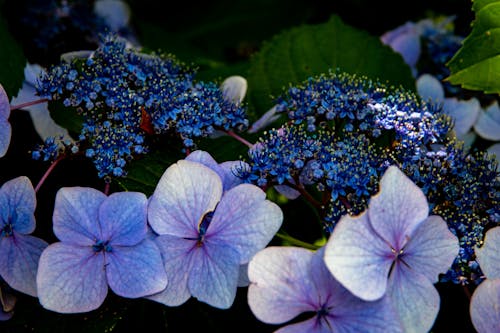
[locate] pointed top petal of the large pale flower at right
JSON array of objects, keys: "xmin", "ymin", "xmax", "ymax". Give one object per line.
[{"xmin": 368, "ymin": 166, "xmax": 429, "ymax": 251}]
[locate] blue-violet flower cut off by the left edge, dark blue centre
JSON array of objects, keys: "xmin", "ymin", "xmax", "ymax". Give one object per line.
[{"xmin": 0, "ymin": 176, "xmax": 48, "ymax": 297}]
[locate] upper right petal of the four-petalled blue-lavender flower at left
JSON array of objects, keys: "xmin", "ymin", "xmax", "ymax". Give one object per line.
[{"xmin": 99, "ymin": 192, "xmax": 148, "ymax": 246}]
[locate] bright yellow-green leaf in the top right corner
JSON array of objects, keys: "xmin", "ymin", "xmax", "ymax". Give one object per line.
[{"xmin": 446, "ymin": 0, "xmax": 500, "ymax": 94}]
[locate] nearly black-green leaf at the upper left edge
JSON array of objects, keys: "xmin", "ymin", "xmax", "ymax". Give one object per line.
[{"xmin": 0, "ymin": 16, "xmax": 26, "ymax": 98}]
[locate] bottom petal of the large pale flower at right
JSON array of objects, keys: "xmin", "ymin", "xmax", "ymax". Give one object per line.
[{"xmin": 387, "ymin": 262, "xmax": 441, "ymax": 332}]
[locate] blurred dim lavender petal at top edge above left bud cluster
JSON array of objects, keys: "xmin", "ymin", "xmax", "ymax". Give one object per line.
[{"xmin": 94, "ymin": 0, "xmax": 130, "ymax": 31}]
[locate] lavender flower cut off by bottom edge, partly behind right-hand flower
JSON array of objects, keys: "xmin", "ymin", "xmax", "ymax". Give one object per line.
[{"xmin": 248, "ymin": 247, "xmax": 402, "ymax": 333}]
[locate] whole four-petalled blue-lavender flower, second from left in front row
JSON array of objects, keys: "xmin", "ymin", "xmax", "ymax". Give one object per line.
[{"xmin": 37, "ymin": 187, "xmax": 167, "ymax": 313}]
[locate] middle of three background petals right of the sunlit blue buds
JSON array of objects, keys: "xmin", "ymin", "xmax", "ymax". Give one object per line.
[{"xmin": 443, "ymin": 98, "xmax": 481, "ymax": 139}]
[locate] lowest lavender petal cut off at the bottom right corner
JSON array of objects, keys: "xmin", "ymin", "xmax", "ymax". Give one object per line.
[{"xmin": 470, "ymin": 279, "xmax": 500, "ymax": 333}]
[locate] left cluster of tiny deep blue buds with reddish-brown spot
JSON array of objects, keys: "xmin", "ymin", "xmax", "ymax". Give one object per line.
[{"xmin": 37, "ymin": 35, "xmax": 248, "ymax": 178}]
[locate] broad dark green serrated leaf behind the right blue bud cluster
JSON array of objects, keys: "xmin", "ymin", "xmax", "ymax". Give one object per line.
[{"xmin": 248, "ymin": 16, "xmax": 415, "ymax": 114}]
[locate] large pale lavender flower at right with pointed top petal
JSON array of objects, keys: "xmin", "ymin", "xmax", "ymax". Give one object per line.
[{"xmin": 325, "ymin": 166, "xmax": 459, "ymax": 332}]
